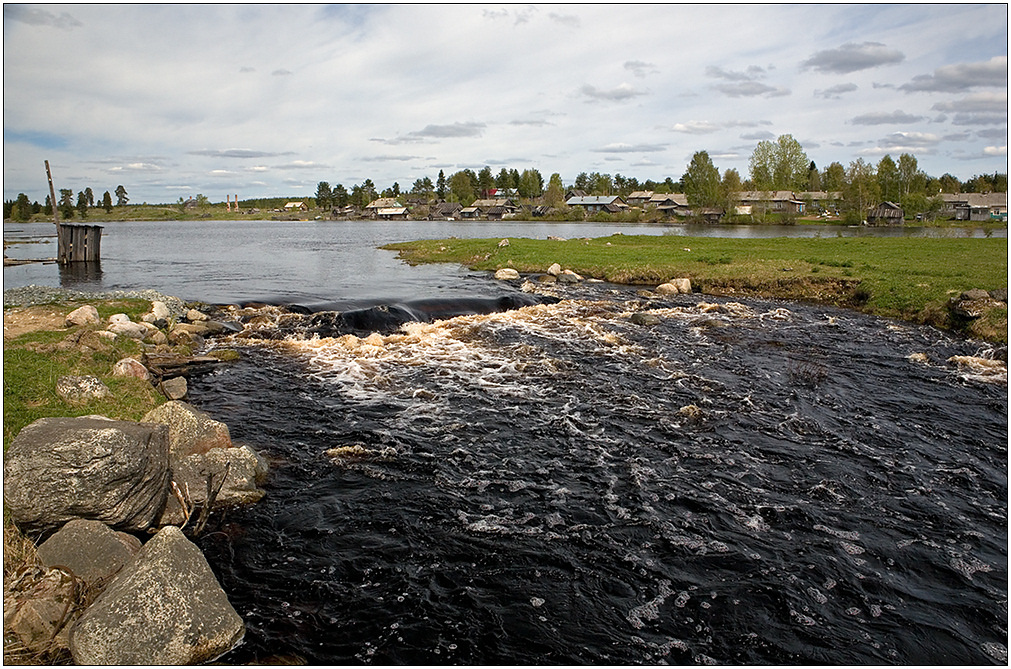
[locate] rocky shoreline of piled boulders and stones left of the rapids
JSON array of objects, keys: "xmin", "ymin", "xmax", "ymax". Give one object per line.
[{"xmin": 4, "ymin": 286, "xmax": 267, "ymax": 665}]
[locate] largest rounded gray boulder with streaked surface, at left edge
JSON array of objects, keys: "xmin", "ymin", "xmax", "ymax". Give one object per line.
[{"xmin": 3, "ymin": 416, "xmax": 170, "ymax": 532}]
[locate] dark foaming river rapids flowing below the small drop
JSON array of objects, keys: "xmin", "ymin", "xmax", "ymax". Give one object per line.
[{"xmin": 191, "ymin": 285, "xmax": 1008, "ymax": 665}]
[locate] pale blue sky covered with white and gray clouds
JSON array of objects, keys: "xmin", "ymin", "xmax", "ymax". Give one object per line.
[{"xmin": 3, "ymin": 4, "xmax": 1008, "ymax": 203}]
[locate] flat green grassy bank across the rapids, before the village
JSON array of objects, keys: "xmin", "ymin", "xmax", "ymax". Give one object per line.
[{"xmin": 383, "ymin": 234, "xmax": 1008, "ymax": 343}]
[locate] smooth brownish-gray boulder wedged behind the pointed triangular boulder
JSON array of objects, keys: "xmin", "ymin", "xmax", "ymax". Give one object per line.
[{"xmin": 38, "ymin": 518, "xmax": 141, "ymax": 588}]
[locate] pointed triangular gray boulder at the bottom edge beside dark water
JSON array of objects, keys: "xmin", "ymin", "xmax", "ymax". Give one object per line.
[{"xmin": 70, "ymin": 527, "xmax": 246, "ymax": 665}]
